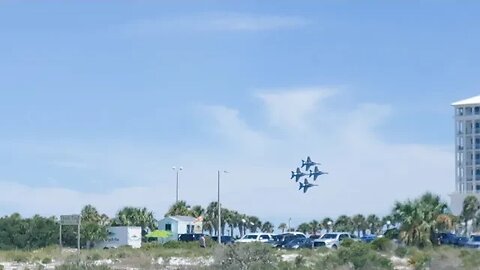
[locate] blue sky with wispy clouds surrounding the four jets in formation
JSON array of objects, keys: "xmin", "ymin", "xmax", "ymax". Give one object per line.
[{"xmin": 0, "ymin": 1, "xmax": 480, "ymax": 227}]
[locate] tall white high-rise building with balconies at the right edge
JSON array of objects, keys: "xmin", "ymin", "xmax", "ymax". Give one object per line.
[{"xmin": 450, "ymin": 96, "xmax": 480, "ymax": 215}]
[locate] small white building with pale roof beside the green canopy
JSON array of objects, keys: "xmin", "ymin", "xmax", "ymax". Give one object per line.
[{"xmin": 158, "ymin": 216, "xmax": 203, "ymax": 241}]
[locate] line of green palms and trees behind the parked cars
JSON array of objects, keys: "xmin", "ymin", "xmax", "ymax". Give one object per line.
[{"xmin": 0, "ymin": 193, "xmax": 480, "ymax": 250}]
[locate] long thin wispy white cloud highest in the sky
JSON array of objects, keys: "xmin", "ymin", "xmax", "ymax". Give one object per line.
[{"xmin": 123, "ymin": 13, "xmax": 309, "ymax": 35}]
